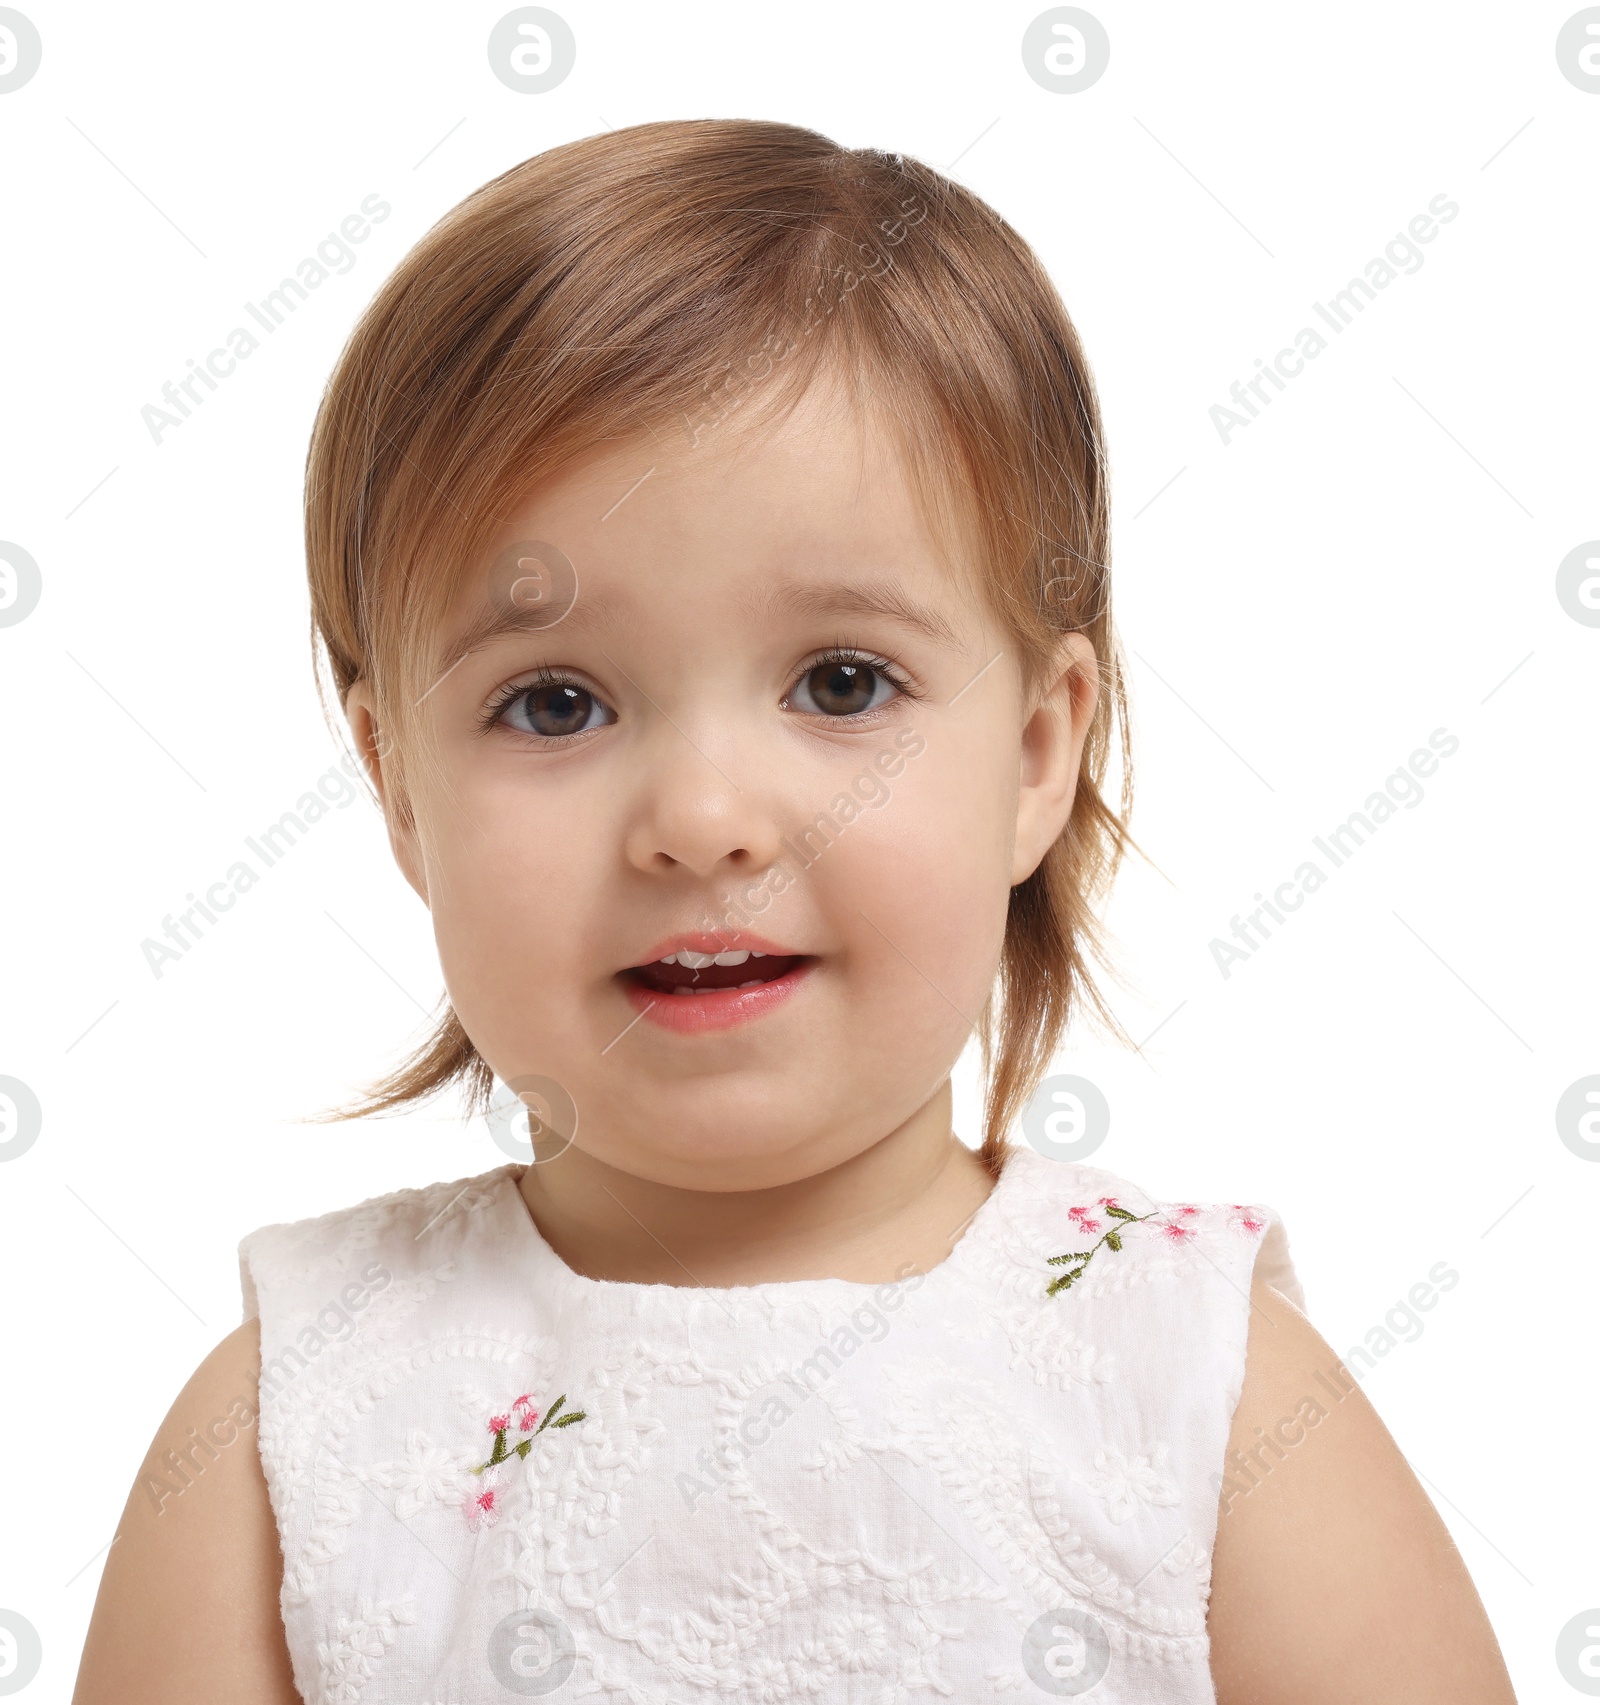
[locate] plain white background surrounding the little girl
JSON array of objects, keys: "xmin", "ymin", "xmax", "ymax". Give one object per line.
[{"xmin": 0, "ymin": 0, "xmax": 1600, "ymax": 1702}]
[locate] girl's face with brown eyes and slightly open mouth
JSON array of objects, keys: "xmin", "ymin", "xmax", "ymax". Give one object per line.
[{"xmin": 350, "ymin": 389, "xmax": 1095, "ymax": 1190}]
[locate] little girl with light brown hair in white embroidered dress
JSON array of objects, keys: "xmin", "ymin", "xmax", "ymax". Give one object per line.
[{"xmin": 77, "ymin": 121, "xmax": 1511, "ymax": 1705}]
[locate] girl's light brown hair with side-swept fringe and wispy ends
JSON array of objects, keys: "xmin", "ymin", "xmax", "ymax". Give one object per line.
[{"xmin": 305, "ymin": 119, "xmax": 1131, "ymax": 1170}]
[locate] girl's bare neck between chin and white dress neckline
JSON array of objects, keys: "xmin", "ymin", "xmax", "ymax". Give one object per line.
[{"xmin": 522, "ymin": 1081, "xmax": 994, "ymax": 1287}]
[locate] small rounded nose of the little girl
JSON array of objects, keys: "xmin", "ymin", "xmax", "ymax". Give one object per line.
[{"xmin": 626, "ymin": 726, "xmax": 781, "ymax": 876}]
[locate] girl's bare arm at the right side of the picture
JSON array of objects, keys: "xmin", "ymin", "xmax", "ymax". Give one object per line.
[{"xmin": 1209, "ymin": 1280, "xmax": 1515, "ymax": 1705}]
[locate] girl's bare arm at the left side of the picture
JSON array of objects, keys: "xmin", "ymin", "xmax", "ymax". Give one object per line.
[{"xmin": 73, "ymin": 1321, "xmax": 300, "ymax": 1705}]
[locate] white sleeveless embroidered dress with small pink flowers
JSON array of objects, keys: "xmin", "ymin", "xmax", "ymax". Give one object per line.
[{"xmin": 241, "ymin": 1149, "xmax": 1303, "ymax": 1705}]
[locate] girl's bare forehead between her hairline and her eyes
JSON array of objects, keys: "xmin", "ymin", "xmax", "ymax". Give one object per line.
[{"xmin": 450, "ymin": 376, "xmax": 981, "ymax": 655}]
